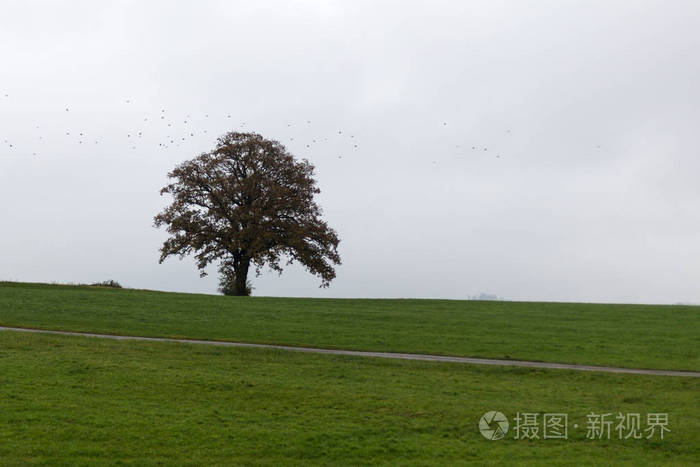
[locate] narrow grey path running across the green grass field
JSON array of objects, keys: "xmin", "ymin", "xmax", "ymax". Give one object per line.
[{"xmin": 0, "ymin": 326, "xmax": 700, "ymax": 378}]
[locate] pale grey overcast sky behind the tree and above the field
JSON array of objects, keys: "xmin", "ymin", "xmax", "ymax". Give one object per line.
[{"xmin": 0, "ymin": 0, "xmax": 700, "ymax": 303}]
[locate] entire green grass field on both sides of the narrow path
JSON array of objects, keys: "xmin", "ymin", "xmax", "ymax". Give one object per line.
[{"xmin": 0, "ymin": 283, "xmax": 700, "ymax": 466}]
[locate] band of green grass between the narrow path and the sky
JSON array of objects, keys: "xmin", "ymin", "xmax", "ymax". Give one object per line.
[{"xmin": 0, "ymin": 283, "xmax": 700, "ymax": 371}]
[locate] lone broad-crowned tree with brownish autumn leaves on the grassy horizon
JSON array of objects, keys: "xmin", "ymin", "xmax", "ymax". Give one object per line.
[{"xmin": 155, "ymin": 132, "xmax": 340, "ymax": 295}]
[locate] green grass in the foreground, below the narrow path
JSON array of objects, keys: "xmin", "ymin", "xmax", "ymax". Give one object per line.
[{"xmin": 0, "ymin": 332, "xmax": 700, "ymax": 466}]
